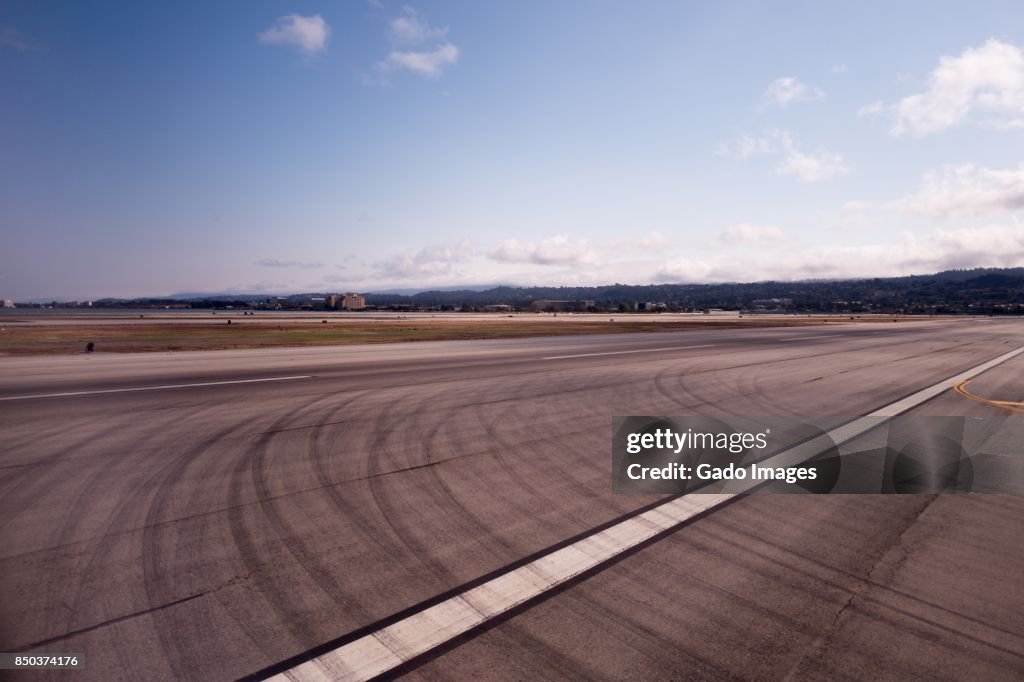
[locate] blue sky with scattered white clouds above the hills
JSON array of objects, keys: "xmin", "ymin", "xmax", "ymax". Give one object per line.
[{"xmin": 0, "ymin": 0, "xmax": 1024, "ymax": 299}]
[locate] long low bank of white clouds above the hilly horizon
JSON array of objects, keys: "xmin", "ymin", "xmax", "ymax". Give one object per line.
[{"xmin": 247, "ymin": 219, "xmax": 1024, "ymax": 291}]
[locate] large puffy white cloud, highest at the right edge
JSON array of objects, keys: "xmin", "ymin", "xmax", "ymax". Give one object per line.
[{"xmin": 872, "ymin": 38, "xmax": 1024, "ymax": 137}]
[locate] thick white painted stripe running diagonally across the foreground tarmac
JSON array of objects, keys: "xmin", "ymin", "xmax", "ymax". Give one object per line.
[{"xmin": 270, "ymin": 346, "xmax": 1024, "ymax": 682}]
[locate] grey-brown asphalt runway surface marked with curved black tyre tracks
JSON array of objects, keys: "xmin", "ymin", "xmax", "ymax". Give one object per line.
[{"xmin": 0, "ymin": 319, "xmax": 1024, "ymax": 680}]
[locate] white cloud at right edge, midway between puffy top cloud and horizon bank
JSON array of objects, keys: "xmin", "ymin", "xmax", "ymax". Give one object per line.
[{"xmin": 894, "ymin": 162, "xmax": 1024, "ymax": 217}]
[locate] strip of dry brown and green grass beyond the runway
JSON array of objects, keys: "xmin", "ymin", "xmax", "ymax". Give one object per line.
[{"xmin": 0, "ymin": 315, "xmax": 929, "ymax": 355}]
